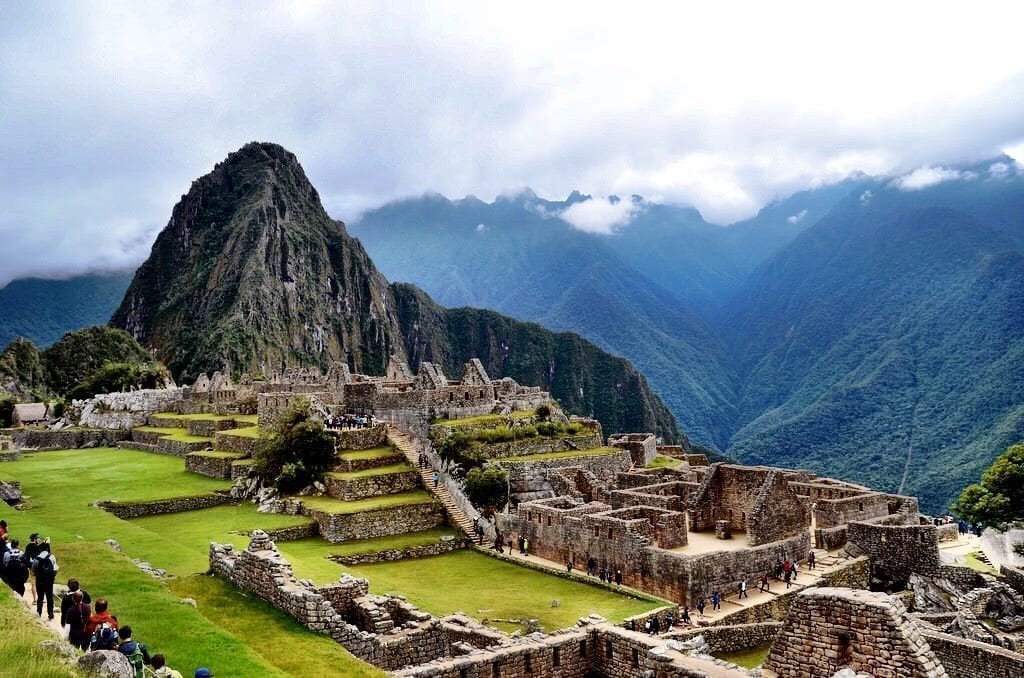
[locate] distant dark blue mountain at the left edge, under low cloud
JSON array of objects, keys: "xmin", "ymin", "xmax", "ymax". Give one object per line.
[{"xmin": 0, "ymin": 271, "xmax": 132, "ymax": 346}]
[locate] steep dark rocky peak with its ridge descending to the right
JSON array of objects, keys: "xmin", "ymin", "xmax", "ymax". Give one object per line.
[{"xmin": 111, "ymin": 143, "xmax": 679, "ymax": 439}]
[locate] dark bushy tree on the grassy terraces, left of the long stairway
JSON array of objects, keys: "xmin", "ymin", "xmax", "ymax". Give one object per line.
[{"xmin": 253, "ymin": 397, "xmax": 336, "ymax": 493}]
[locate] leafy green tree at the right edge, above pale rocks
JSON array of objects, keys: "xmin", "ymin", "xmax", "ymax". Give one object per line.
[{"xmin": 952, "ymin": 443, "xmax": 1024, "ymax": 527}]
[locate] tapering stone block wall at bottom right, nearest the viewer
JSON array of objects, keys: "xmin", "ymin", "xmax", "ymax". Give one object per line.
[{"xmin": 764, "ymin": 587, "xmax": 947, "ymax": 678}]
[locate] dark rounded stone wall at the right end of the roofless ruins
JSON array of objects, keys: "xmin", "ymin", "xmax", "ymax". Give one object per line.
[{"xmin": 847, "ymin": 522, "xmax": 941, "ymax": 583}]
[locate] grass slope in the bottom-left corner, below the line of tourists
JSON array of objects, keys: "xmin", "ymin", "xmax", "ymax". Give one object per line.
[{"xmin": 0, "ymin": 584, "xmax": 83, "ymax": 678}]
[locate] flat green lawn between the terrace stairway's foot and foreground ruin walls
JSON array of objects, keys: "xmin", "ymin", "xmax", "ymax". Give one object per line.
[{"xmin": 279, "ymin": 541, "xmax": 664, "ymax": 631}]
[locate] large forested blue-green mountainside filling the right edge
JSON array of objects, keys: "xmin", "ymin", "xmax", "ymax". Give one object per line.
[{"xmin": 722, "ymin": 172, "xmax": 1024, "ymax": 510}]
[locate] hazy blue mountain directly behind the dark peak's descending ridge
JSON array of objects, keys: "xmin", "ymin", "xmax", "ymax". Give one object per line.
[{"xmin": 352, "ymin": 192, "xmax": 735, "ymax": 448}]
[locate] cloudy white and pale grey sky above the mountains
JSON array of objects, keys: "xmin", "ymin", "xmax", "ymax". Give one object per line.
[{"xmin": 0, "ymin": 0, "xmax": 1024, "ymax": 285}]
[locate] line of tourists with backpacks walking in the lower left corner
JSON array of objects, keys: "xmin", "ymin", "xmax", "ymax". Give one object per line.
[{"xmin": 0, "ymin": 520, "xmax": 213, "ymax": 678}]
